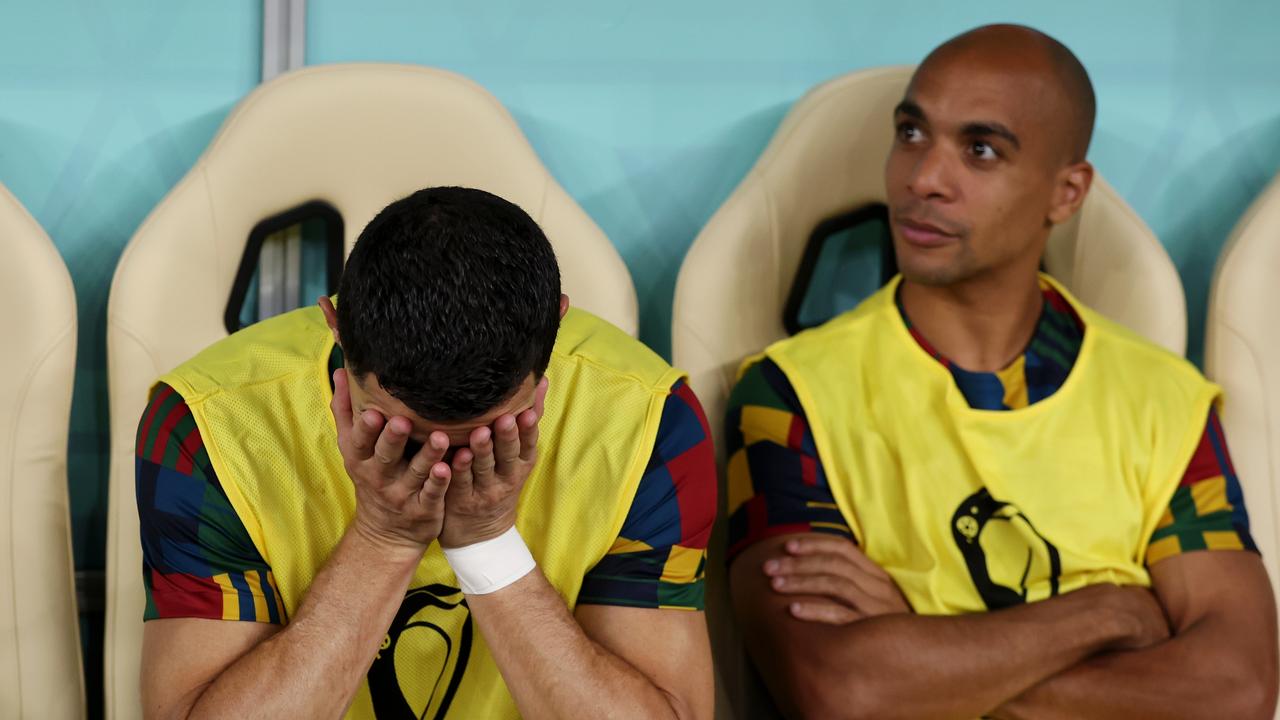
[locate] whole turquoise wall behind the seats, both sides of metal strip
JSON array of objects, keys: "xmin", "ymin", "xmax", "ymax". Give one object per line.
[{"xmin": 0, "ymin": 0, "xmax": 1280, "ymax": 712}]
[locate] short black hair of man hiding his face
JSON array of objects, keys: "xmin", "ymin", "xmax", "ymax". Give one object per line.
[{"xmin": 338, "ymin": 187, "xmax": 561, "ymax": 423}]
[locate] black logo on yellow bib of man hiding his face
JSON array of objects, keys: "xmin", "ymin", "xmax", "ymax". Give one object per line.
[{"xmin": 369, "ymin": 584, "xmax": 472, "ymax": 720}]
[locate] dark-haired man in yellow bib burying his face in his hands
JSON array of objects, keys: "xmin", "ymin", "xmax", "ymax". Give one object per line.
[{"xmin": 137, "ymin": 188, "xmax": 716, "ymax": 719}]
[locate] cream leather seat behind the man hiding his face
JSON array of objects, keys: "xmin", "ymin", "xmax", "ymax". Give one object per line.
[{"xmin": 105, "ymin": 64, "xmax": 637, "ymax": 719}]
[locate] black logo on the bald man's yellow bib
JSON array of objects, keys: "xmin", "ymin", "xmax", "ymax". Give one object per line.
[{"xmin": 951, "ymin": 488, "xmax": 1062, "ymax": 610}]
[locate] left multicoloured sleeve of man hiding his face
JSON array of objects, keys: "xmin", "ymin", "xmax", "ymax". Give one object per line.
[{"xmin": 134, "ymin": 384, "xmax": 285, "ymax": 624}]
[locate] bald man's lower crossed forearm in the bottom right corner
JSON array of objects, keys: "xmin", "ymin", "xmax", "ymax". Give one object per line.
[{"xmin": 996, "ymin": 609, "xmax": 1276, "ymax": 720}]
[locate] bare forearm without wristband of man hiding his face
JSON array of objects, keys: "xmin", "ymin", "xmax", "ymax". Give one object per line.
[{"xmin": 188, "ymin": 525, "xmax": 421, "ymax": 719}]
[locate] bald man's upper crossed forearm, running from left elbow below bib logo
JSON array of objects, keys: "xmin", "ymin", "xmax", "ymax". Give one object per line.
[{"xmin": 749, "ymin": 591, "xmax": 1130, "ymax": 719}]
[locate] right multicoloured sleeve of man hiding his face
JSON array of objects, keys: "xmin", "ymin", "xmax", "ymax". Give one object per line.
[{"xmin": 577, "ymin": 380, "xmax": 716, "ymax": 610}]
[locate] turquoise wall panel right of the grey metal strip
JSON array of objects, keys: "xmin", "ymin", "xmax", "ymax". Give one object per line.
[{"xmin": 307, "ymin": 0, "xmax": 1280, "ymax": 359}]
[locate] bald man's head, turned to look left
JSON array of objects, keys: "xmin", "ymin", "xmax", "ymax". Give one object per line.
[{"xmin": 884, "ymin": 26, "xmax": 1094, "ymax": 287}]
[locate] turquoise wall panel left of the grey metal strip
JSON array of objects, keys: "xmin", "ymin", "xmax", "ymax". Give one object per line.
[{"xmin": 0, "ymin": 0, "xmax": 261, "ymax": 569}]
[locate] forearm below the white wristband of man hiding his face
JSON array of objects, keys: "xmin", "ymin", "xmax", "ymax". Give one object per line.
[{"xmin": 467, "ymin": 570, "xmax": 687, "ymax": 720}]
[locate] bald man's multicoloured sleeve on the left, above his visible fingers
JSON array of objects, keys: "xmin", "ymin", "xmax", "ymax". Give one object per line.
[{"xmin": 726, "ymin": 359, "xmax": 852, "ymax": 561}]
